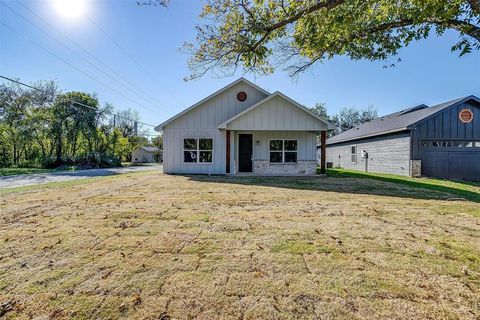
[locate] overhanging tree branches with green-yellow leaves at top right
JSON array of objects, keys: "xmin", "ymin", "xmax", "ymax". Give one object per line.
[{"xmin": 174, "ymin": 0, "xmax": 480, "ymax": 79}]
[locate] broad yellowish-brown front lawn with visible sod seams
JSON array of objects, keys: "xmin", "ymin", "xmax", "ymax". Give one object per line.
[{"xmin": 0, "ymin": 172, "xmax": 480, "ymax": 320}]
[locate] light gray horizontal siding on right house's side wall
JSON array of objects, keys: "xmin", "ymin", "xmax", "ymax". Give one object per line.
[{"xmin": 327, "ymin": 133, "xmax": 410, "ymax": 176}]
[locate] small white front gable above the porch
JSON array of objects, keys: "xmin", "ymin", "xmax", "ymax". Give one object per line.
[{"xmin": 218, "ymin": 91, "xmax": 334, "ymax": 131}]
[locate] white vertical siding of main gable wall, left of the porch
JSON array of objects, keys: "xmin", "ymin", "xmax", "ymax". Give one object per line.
[{"xmin": 163, "ymin": 82, "xmax": 267, "ymax": 174}]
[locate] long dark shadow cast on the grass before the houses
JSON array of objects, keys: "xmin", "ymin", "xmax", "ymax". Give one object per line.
[{"xmin": 184, "ymin": 170, "xmax": 480, "ymax": 203}]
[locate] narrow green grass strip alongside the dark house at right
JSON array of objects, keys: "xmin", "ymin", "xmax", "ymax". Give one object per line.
[{"xmin": 327, "ymin": 169, "xmax": 480, "ymax": 202}]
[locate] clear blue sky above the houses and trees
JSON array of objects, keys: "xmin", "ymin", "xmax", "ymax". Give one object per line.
[{"xmin": 0, "ymin": 0, "xmax": 480, "ymax": 136}]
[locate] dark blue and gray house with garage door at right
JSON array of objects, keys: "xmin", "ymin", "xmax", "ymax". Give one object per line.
[{"xmin": 327, "ymin": 96, "xmax": 480, "ymax": 181}]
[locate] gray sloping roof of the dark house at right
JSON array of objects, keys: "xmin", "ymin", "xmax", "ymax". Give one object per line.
[{"xmin": 327, "ymin": 95, "xmax": 480, "ymax": 145}]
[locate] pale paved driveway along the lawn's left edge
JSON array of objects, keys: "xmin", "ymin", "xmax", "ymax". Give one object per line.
[{"xmin": 0, "ymin": 165, "xmax": 162, "ymax": 189}]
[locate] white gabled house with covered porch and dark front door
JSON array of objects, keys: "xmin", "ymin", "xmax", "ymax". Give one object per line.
[{"xmin": 155, "ymin": 78, "xmax": 332, "ymax": 175}]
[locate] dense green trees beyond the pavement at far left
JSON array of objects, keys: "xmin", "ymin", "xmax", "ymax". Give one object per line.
[{"xmin": 0, "ymin": 81, "xmax": 152, "ymax": 168}]
